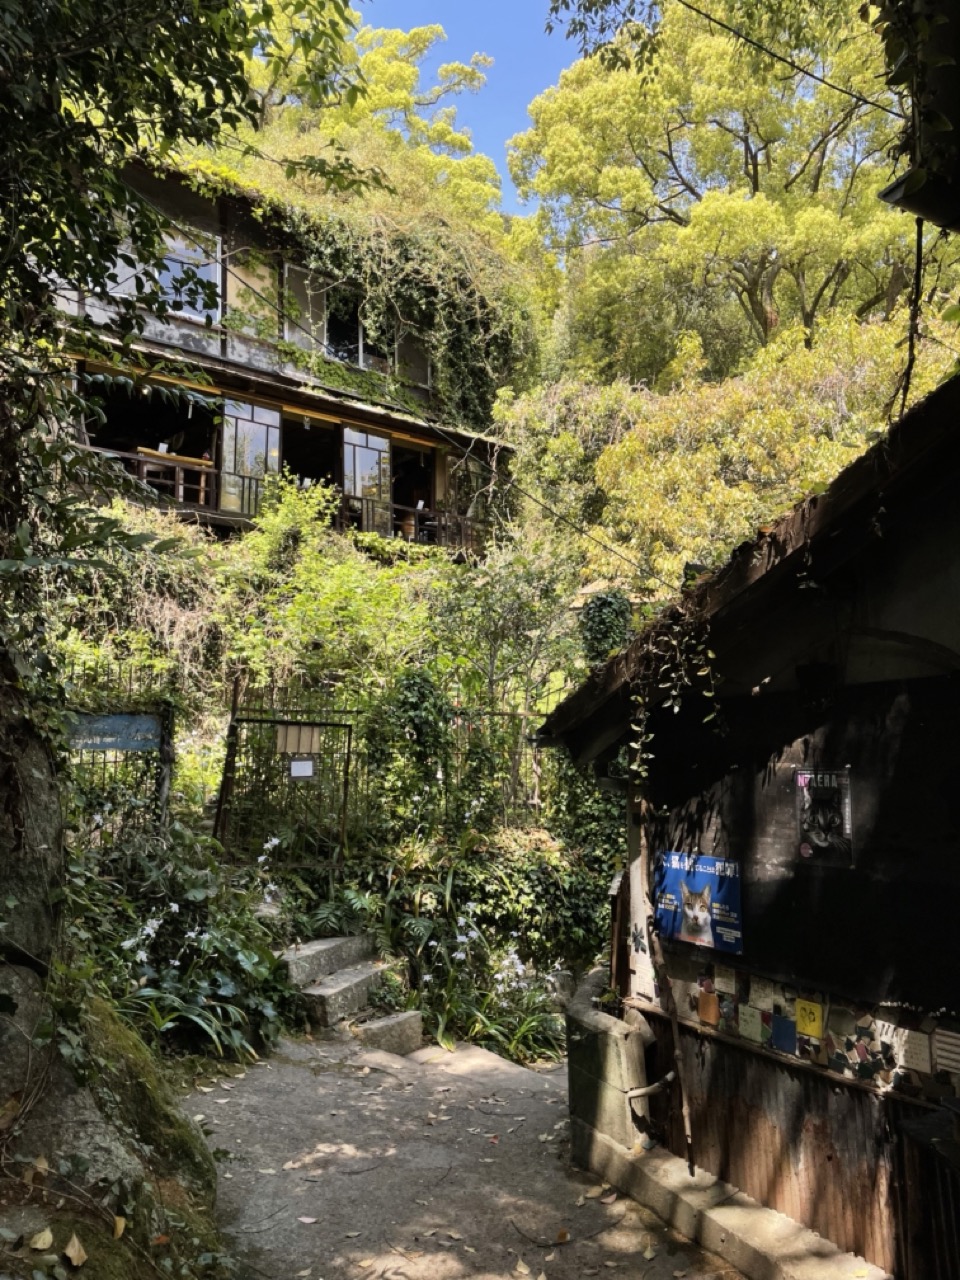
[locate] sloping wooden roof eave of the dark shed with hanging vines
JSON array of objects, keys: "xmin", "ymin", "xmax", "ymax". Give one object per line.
[{"xmin": 538, "ymin": 375, "xmax": 960, "ymax": 762}]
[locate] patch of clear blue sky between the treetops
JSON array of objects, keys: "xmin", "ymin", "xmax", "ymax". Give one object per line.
[{"xmin": 357, "ymin": 0, "xmax": 576, "ymax": 212}]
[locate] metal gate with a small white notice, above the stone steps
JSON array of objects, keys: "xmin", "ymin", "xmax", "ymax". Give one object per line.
[{"xmin": 215, "ymin": 716, "xmax": 353, "ymax": 865}]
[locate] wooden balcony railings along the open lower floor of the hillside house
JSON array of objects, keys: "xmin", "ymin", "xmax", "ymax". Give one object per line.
[{"xmin": 85, "ymin": 447, "xmax": 486, "ymax": 554}]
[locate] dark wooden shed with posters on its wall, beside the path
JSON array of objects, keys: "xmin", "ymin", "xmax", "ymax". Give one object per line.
[{"xmin": 541, "ymin": 379, "xmax": 960, "ymax": 1280}]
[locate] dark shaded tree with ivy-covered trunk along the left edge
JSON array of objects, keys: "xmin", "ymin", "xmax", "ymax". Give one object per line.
[{"xmin": 0, "ymin": 0, "xmax": 358, "ymax": 1075}]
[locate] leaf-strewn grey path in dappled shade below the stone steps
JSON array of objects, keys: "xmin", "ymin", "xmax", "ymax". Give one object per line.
[{"xmin": 186, "ymin": 1037, "xmax": 741, "ymax": 1280}]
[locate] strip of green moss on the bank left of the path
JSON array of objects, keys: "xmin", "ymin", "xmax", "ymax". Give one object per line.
[{"xmin": 86, "ymin": 1001, "xmax": 216, "ymax": 1208}]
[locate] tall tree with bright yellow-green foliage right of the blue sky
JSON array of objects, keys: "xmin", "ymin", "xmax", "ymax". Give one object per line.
[{"xmin": 511, "ymin": 5, "xmax": 911, "ymax": 378}]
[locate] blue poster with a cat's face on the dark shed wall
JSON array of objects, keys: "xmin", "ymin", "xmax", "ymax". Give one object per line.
[{"xmin": 657, "ymin": 854, "xmax": 744, "ymax": 955}]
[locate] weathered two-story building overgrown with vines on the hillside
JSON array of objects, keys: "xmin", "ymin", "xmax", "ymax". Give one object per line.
[{"xmin": 68, "ymin": 169, "xmax": 498, "ymax": 550}]
